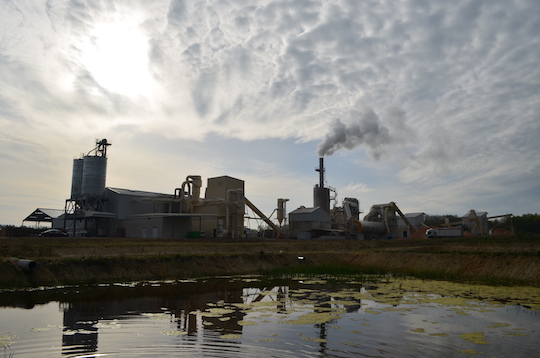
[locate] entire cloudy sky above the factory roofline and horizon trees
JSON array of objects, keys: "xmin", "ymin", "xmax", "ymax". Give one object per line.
[{"xmin": 0, "ymin": 0, "xmax": 540, "ymax": 225}]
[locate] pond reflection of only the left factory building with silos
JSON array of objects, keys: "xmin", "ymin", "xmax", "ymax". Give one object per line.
[{"xmin": 61, "ymin": 284, "xmax": 244, "ymax": 355}]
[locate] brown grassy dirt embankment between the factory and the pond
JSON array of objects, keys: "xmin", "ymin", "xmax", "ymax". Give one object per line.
[{"xmin": 0, "ymin": 236, "xmax": 540, "ymax": 287}]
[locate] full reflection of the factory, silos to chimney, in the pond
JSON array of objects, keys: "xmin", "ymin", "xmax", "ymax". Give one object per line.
[{"xmin": 52, "ymin": 281, "xmax": 361, "ymax": 356}]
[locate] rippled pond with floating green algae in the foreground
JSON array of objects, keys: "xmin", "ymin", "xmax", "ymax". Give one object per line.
[{"xmin": 0, "ymin": 276, "xmax": 540, "ymax": 358}]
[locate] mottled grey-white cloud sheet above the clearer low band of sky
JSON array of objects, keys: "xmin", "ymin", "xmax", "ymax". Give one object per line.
[{"xmin": 0, "ymin": 0, "xmax": 540, "ymax": 224}]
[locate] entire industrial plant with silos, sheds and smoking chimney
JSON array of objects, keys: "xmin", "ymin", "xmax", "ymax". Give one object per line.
[{"xmin": 24, "ymin": 139, "xmax": 500, "ymax": 240}]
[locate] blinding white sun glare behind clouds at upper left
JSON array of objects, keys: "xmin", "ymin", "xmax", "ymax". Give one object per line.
[{"xmin": 82, "ymin": 22, "xmax": 152, "ymax": 96}]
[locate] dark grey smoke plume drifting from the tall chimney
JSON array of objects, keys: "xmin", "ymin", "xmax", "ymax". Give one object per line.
[{"xmin": 317, "ymin": 110, "xmax": 391, "ymax": 159}]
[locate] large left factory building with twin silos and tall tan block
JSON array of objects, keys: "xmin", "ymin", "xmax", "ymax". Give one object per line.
[{"xmin": 52, "ymin": 139, "xmax": 245, "ymax": 238}]
